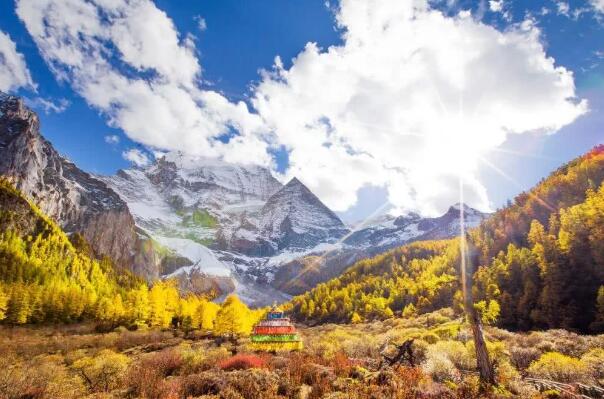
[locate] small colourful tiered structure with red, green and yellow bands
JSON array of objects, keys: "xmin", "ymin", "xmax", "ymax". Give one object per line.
[{"xmin": 250, "ymin": 306, "xmax": 303, "ymax": 352}]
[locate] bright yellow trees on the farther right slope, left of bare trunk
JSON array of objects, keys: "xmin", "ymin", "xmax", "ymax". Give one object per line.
[{"xmin": 291, "ymin": 240, "xmax": 459, "ymax": 322}]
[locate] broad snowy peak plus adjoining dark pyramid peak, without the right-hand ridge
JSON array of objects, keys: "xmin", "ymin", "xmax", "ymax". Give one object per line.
[{"xmin": 98, "ymin": 153, "xmax": 348, "ymax": 303}]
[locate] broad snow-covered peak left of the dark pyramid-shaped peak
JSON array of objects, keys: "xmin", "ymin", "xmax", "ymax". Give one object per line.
[{"xmin": 99, "ymin": 153, "xmax": 282, "ymax": 276}]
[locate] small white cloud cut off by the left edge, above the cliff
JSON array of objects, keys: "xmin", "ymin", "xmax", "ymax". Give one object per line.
[{"xmin": 0, "ymin": 31, "xmax": 36, "ymax": 91}]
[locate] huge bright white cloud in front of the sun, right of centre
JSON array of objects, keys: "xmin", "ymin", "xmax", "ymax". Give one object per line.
[{"xmin": 253, "ymin": 0, "xmax": 587, "ymax": 213}]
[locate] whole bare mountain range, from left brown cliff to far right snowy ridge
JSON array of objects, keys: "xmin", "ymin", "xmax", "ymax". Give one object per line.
[{"xmin": 0, "ymin": 93, "xmax": 485, "ymax": 305}]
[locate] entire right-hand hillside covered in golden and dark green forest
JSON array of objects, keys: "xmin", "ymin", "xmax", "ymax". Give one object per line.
[{"xmin": 291, "ymin": 146, "xmax": 604, "ymax": 332}]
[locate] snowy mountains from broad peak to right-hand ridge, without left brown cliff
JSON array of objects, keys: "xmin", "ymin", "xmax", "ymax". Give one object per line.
[{"xmin": 100, "ymin": 153, "xmax": 485, "ymax": 304}]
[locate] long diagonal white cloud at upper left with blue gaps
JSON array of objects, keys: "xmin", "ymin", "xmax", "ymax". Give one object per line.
[{"xmin": 16, "ymin": 0, "xmax": 270, "ymax": 164}]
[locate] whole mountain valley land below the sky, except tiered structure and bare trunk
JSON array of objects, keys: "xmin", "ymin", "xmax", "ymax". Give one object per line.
[{"xmin": 0, "ymin": 92, "xmax": 604, "ymax": 399}]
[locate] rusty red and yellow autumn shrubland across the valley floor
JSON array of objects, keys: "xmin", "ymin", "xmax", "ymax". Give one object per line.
[{"xmin": 0, "ymin": 308, "xmax": 604, "ymax": 399}]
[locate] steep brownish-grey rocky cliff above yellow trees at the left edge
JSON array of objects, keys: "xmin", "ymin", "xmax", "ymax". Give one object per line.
[{"xmin": 0, "ymin": 94, "xmax": 157, "ymax": 277}]
